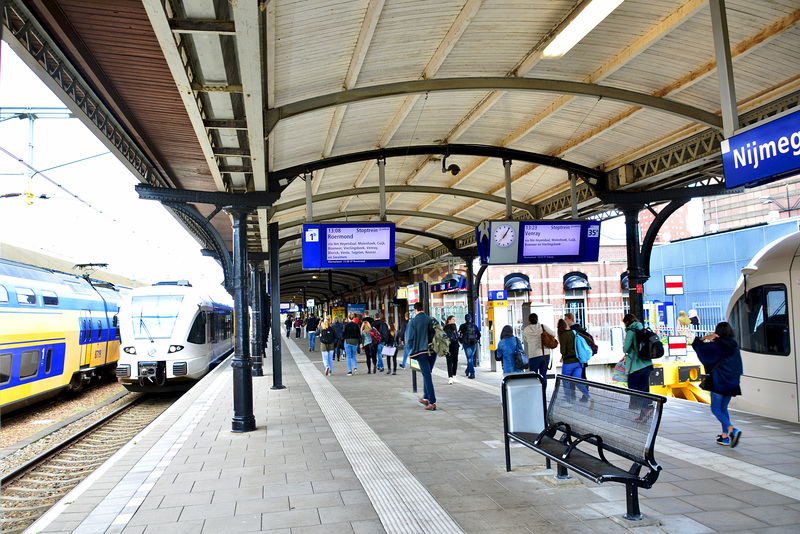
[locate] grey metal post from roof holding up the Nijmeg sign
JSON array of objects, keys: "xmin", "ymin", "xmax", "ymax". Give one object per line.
[{"xmin": 708, "ymin": 0, "xmax": 739, "ymax": 139}]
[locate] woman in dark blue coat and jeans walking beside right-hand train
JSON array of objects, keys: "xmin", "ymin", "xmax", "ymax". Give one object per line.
[{"xmin": 692, "ymin": 322, "xmax": 744, "ymax": 447}]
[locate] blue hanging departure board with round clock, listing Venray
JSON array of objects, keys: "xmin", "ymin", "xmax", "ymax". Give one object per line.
[{"xmin": 475, "ymin": 221, "xmax": 600, "ymax": 265}]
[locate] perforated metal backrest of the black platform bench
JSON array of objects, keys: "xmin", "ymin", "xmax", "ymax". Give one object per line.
[{"xmin": 547, "ymin": 375, "xmax": 667, "ymax": 465}]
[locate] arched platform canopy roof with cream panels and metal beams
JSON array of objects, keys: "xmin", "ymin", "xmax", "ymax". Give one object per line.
[{"xmin": 3, "ymin": 0, "xmax": 800, "ymax": 297}]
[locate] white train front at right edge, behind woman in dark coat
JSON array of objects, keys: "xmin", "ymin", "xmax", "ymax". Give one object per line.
[{"xmin": 726, "ymin": 232, "xmax": 800, "ymax": 422}]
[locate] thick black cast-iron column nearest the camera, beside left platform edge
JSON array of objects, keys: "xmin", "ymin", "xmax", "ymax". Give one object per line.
[{"xmin": 225, "ymin": 206, "xmax": 256, "ymax": 432}]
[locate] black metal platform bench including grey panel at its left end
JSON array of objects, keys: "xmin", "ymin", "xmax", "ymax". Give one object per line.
[{"xmin": 503, "ymin": 373, "xmax": 667, "ymax": 520}]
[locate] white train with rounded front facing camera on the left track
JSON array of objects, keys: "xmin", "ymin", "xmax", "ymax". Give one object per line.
[{"xmin": 117, "ymin": 281, "xmax": 233, "ymax": 391}]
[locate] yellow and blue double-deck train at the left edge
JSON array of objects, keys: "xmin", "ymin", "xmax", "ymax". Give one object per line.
[{"xmin": 0, "ymin": 259, "xmax": 125, "ymax": 413}]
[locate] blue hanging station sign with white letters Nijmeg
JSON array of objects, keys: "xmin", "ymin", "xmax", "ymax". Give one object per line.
[{"xmin": 720, "ymin": 111, "xmax": 800, "ymax": 188}]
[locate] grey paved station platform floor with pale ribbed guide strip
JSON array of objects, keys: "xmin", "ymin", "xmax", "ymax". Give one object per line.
[{"xmin": 29, "ymin": 338, "xmax": 800, "ymax": 534}]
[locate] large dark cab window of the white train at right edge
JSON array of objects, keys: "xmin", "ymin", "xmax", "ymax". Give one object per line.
[{"xmin": 729, "ymin": 284, "xmax": 790, "ymax": 356}]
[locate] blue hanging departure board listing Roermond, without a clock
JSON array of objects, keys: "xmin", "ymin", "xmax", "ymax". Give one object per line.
[{"xmin": 303, "ymin": 223, "xmax": 395, "ymax": 269}]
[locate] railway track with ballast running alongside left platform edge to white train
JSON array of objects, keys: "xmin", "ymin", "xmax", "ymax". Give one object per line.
[{"xmin": 0, "ymin": 395, "xmax": 179, "ymax": 534}]
